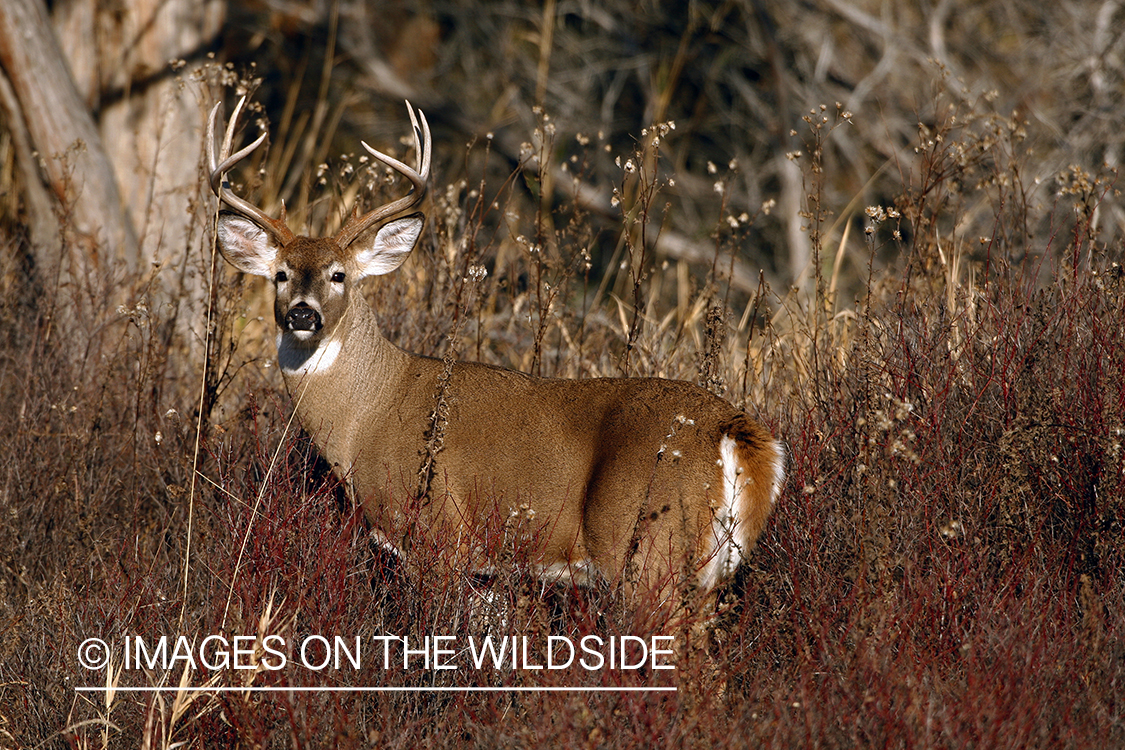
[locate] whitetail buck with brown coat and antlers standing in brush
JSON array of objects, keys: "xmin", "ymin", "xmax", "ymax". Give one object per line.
[{"xmin": 207, "ymin": 95, "xmax": 783, "ymax": 611}]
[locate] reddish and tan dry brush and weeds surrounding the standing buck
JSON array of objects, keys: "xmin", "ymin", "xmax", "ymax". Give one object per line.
[{"xmin": 0, "ymin": 26, "xmax": 1125, "ymax": 748}]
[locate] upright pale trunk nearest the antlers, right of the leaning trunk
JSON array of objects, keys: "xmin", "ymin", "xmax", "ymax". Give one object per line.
[{"xmin": 52, "ymin": 0, "xmax": 225, "ymax": 273}]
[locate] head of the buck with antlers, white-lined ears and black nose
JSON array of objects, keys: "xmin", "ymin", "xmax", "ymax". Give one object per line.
[{"xmin": 207, "ymin": 98, "xmax": 430, "ymax": 349}]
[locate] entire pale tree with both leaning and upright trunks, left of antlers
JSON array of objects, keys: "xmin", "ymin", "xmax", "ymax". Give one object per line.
[{"xmin": 0, "ymin": 0, "xmax": 225, "ymax": 360}]
